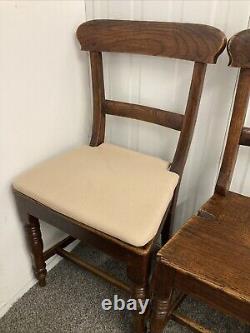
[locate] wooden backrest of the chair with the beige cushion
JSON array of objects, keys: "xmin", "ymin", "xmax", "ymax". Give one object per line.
[{"xmin": 77, "ymin": 20, "xmax": 226, "ymax": 175}]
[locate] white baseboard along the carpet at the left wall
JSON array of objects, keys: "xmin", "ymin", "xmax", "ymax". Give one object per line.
[{"xmin": 0, "ymin": 240, "xmax": 79, "ymax": 318}]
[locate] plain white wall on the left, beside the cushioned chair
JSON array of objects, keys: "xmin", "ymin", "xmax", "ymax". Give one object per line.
[{"xmin": 0, "ymin": 1, "xmax": 91, "ymax": 315}]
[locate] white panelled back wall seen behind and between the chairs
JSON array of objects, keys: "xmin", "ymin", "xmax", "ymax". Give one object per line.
[{"xmin": 86, "ymin": 0, "xmax": 250, "ymax": 229}]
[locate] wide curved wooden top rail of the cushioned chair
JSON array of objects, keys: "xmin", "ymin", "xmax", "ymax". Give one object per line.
[{"xmin": 77, "ymin": 20, "xmax": 226, "ymax": 63}]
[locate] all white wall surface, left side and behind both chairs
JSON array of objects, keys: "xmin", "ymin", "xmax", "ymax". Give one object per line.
[{"xmin": 0, "ymin": 0, "xmax": 250, "ymax": 316}]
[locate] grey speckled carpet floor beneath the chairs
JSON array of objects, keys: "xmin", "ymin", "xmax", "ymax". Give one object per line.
[{"xmin": 0, "ymin": 246, "xmax": 250, "ymax": 333}]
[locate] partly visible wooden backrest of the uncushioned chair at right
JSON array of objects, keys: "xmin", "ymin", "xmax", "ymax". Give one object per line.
[{"xmin": 215, "ymin": 29, "xmax": 250, "ymax": 195}]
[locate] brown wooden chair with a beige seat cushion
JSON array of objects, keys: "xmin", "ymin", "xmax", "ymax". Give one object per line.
[{"xmin": 13, "ymin": 20, "xmax": 226, "ymax": 332}]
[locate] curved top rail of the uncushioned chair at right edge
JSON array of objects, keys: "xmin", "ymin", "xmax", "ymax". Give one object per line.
[{"xmin": 227, "ymin": 29, "xmax": 250, "ymax": 68}]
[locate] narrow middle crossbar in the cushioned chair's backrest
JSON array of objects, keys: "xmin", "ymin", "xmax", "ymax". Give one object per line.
[{"xmin": 104, "ymin": 100, "xmax": 184, "ymax": 131}]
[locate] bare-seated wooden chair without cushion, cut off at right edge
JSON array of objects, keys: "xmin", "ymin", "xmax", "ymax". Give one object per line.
[{"xmin": 151, "ymin": 30, "xmax": 250, "ymax": 333}]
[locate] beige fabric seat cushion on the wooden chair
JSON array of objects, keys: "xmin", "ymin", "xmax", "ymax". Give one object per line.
[{"xmin": 13, "ymin": 143, "xmax": 179, "ymax": 246}]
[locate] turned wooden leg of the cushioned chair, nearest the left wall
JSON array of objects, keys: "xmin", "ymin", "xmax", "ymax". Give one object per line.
[{"xmin": 26, "ymin": 215, "xmax": 47, "ymax": 287}]
